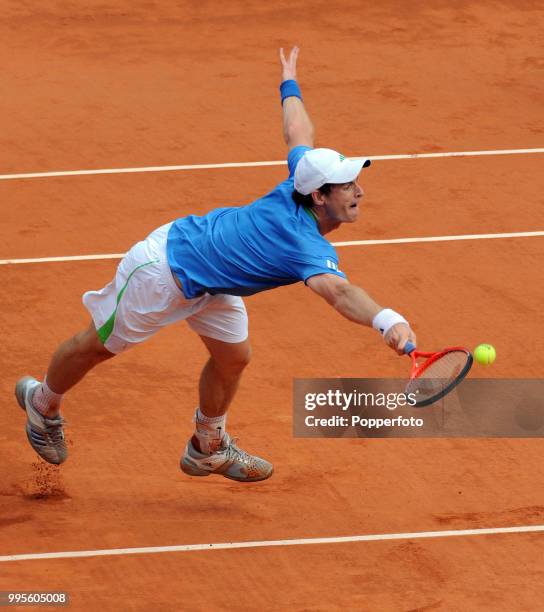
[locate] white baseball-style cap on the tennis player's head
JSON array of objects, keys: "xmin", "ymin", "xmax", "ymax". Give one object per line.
[{"xmin": 295, "ymin": 149, "xmax": 370, "ymax": 195}]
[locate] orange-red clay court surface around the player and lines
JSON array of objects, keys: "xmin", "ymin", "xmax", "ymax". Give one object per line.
[{"xmin": 0, "ymin": 0, "xmax": 544, "ymax": 612}]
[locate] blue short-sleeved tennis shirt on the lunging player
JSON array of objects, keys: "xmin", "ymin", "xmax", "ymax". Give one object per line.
[{"xmin": 166, "ymin": 146, "xmax": 345, "ymax": 299}]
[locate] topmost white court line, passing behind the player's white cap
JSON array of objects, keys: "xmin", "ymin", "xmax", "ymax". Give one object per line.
[{"xmin": 0, "ymin": 148, "xmax": 544, "ymax": 181}]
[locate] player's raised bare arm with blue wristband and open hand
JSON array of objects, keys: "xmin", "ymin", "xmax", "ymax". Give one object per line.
[{"xmin": 280, "ymin": 47, "xmax": 314, "ymax": 150}]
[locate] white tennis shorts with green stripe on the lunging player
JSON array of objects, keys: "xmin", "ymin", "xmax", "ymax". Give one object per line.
[{"xmin": 83, "ymin": 223, "xmax": 248, "ymax": 353}]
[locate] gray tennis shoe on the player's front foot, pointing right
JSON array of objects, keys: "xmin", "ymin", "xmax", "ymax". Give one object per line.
[{"xmin": 180, "ymin": 434, "xmax": 274, "ymax": 482}]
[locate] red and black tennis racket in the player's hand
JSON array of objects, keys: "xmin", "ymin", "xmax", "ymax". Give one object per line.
[{"xmin": 404, "ymin": 342, "xmax": 473, "ymax": 407}]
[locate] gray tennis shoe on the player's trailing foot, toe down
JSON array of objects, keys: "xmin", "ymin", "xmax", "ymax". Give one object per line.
[{"xmin": 15, "ymin": 376, "xmax": 68, "ymax": 465}]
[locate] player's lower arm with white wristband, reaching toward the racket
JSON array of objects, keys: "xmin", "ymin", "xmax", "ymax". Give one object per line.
[{"xmin": 306, "ymin": 274, "xmax": 417, "ymax": 355}]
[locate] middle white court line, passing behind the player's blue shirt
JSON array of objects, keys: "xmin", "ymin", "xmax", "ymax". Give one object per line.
[{"xmin": 0, "ymin": 231, "xmax": 544, "ymax": 265}]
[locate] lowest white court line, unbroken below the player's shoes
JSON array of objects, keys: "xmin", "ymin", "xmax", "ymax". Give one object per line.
[{"xmin": 0, "ymin": 525, "xmax": 544, "ymax": 562}]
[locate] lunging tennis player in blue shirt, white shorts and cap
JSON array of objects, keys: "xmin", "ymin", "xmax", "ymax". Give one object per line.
[{"xmin": 15, "ymin": 47, "xmax": 416, "ymax": 482}]
